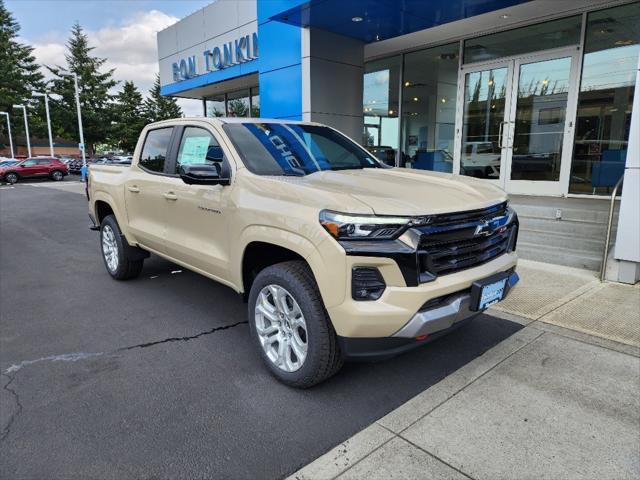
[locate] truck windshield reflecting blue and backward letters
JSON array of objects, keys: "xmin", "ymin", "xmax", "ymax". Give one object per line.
[{"xmin": 224, "ymin": 123, "xmax": 383, "ymax": 176}]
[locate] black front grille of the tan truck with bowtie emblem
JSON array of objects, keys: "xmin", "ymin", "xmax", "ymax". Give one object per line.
[{"xmin": 418, "ymin": 202, "xmax": 518, "ymax": 280}]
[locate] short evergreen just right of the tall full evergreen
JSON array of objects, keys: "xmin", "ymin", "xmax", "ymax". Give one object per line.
[{"xmin": 109, "ymin": 81, "xmax": 145, "ymax": 153}]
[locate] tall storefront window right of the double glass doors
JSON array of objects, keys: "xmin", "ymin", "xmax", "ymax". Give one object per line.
[{"xmin": 569, "ymin": 3, "xmax": 640, "ymax": 195}]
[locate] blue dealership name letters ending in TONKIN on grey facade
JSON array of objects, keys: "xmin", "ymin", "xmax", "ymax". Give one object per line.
[{"xmin": 172, "ymin": 32, "xmax": 258, "ymax": 82}]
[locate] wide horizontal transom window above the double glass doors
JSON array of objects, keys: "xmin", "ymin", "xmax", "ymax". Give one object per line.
[{"xmin": 464, "ymin": 15, "xmax": 582, "ymax": 63}]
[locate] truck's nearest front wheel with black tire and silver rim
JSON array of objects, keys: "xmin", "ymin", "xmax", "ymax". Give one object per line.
[{"xmin": 248, "ymin": 261, "xmax": 343, "ymax": 388}]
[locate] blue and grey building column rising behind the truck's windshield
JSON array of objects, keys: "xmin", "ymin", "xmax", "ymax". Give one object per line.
[{"xmin": 257, "ymin": 5, "xmax": 364, "ymax": 139}]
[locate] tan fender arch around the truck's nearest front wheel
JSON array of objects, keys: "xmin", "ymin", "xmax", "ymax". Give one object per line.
[{"xmin": 230, "ymin": 225, "xmax": 346, "ymax": 307}]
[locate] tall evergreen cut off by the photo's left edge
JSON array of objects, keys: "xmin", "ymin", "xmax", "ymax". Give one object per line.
[{"xmin": 0, "ymin": 0, "xmax": 44, "ymax": 143}]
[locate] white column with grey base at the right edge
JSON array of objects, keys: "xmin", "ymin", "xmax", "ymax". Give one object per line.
[{"xmin": 614, "ymin": 52, "xmax": 640, "ymax": 284}]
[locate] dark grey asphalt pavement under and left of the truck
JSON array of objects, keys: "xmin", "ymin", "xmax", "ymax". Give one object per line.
[{"xmin": 0, "ymin": 182, "xmax": 522, "ymax": 479}]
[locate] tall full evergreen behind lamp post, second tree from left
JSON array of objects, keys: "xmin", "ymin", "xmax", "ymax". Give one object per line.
[{"xmin": 47, "ymin": 23, "xmax": 118, "ymax": 154}]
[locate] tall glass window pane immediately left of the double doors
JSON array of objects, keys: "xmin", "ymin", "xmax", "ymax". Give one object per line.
[{"xmin": 400, "ymin": 43, "xmax": 460, "ymax": 172}]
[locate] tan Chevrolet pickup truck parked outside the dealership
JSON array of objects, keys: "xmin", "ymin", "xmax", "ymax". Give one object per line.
[{"xmin": 87, "ymin": 118, "xmax": 518, "ymax": 387}]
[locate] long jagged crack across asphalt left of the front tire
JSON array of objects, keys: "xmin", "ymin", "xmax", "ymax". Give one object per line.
[{"xmin": 0, "ymin": 320, "xmax": 249, "ymax": 442}]
